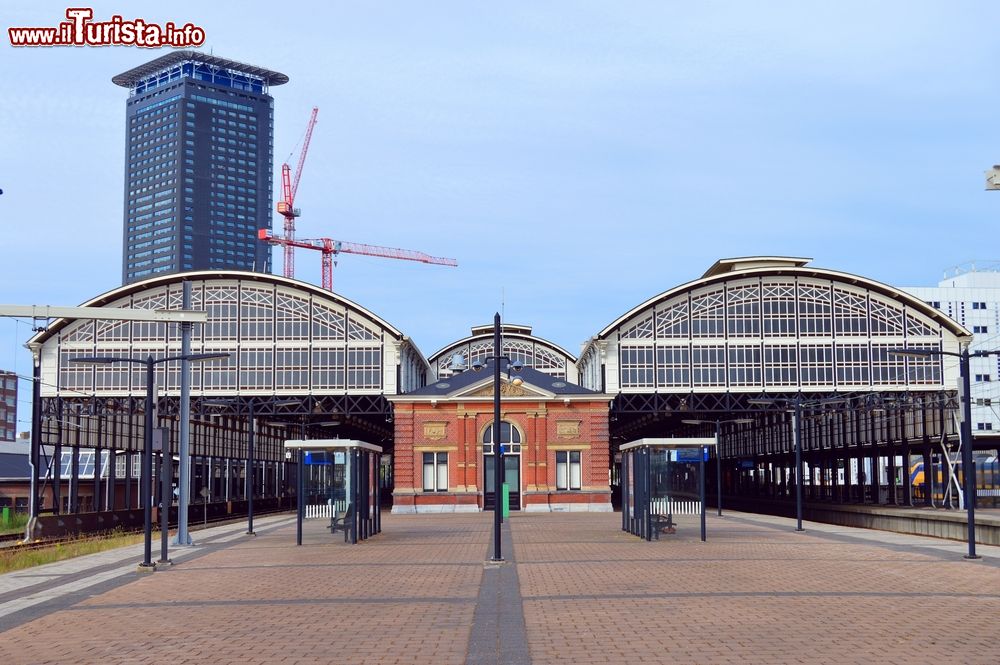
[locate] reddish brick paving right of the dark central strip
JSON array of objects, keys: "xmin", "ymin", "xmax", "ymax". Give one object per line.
[{"xmin": 512, "ymin": 514, "xmax": 1000, "ymax": 665}]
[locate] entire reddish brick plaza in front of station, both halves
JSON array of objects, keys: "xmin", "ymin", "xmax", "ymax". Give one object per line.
[{"xmin": 0, "ymin": 513, "xmax": 1000, "ymax": 665}]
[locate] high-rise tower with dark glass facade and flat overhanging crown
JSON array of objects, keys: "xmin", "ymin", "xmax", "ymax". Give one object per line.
[{"xmin": 112, "ymin": 51, "xmax": 288, "ymax": 284}]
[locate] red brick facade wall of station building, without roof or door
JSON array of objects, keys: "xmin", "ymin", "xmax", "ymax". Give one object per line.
[{"xmin": 390, "ymin": 384, "xmax": 611, "ymax": 513}]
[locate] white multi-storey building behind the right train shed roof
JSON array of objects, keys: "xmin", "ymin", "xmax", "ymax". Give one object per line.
[{"xmin": 903, "ymin": 263, "xmax": 1000, "ymax": 434}]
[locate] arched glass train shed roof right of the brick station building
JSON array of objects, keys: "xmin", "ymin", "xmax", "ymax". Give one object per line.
[{"xmin": 577, "ymin": 256, "xmax": 971, "ymax": 448}]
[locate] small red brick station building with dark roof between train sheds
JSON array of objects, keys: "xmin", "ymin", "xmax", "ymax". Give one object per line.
[{"xmin": 387, "ymin": 359, "xmax": 611, "ymax": 513}]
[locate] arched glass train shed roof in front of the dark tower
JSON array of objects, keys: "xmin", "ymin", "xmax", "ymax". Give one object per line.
[{"xmin": 29, "ymin": 270, "xmax": 429, "ymax": 454}]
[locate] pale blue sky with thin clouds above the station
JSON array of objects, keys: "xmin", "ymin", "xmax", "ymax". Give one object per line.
[{"xmin": 0, "ymin": 0, "xmax": 1000, "ymax": 429}]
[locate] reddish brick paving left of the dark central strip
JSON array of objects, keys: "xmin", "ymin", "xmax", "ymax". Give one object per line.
[{"xmin": 0, "ymin": 515, "xmax": 490, "ymax": 665}]
